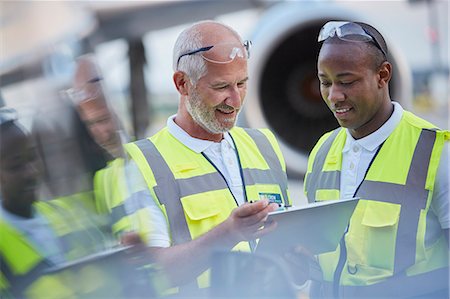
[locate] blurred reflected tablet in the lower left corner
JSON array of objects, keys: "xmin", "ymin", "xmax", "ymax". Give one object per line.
[{"xmin": 42, "ymin": 245, "xmax": 159, "ymax": 298}]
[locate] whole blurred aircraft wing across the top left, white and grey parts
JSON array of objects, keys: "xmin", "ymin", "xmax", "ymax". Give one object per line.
[{"xmin": 0, "ymin": 0, "xmax": 267, "ymax": 86}]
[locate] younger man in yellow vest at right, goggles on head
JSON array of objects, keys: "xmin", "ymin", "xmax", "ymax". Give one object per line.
[{"xmin": 304, "ymin": 22, "xmax": 450, "ymax": 298}]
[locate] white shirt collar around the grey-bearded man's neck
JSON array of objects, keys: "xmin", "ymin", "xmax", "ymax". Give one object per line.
[{"xmin": 167, "ymin": 114, "xmax": 234, "ymax": 153}]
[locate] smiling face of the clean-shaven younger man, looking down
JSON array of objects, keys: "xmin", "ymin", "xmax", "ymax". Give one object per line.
[{"xmin": 317, "ymin": 42, "xmax": 394, "ymax": 139}]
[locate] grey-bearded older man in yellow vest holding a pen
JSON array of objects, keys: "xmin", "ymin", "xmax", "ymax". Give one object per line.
[{"xmin": 127, "ymin": 21, "xmax": 290, "ymax": 288}]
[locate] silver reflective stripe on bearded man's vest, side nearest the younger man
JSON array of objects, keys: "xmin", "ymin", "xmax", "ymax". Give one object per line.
[{"xmin": 243, "ymin": 129, "xmax": 290, "ymax": 207}]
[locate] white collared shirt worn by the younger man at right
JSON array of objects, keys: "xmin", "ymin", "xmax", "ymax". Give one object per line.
[{"xmin": 340, "ymin": 102, "xmax": 450, "ymax": 232}]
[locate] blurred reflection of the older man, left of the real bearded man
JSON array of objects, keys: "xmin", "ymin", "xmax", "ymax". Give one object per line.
[{"xmin": 67, "ymin": 54, "xmax": 156, "ymax": 246}]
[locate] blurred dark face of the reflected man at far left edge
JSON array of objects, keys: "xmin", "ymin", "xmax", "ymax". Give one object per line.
[{"xmin": 0, "ymin": 124, "xmax": 38, "ymax": 218}]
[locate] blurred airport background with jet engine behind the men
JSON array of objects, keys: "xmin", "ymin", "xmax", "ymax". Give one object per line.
[{"xmin": 0, "ymin": 0, "xmax": 450, "ymax": 205}]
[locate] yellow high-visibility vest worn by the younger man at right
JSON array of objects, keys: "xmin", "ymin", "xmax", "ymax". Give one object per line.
[{"xmin": 304, "ymin": 111, "xmax": 450, "ymax": 298}]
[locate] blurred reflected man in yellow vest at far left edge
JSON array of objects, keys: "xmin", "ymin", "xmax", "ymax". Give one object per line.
[{"xmin": 0, "ymin": 108, "xmax": 157, "ymax": 299}]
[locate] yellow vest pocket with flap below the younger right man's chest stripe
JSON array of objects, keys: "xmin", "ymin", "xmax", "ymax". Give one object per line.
[{"xmin": 347, "ymin": 201, "xmax": 401, "ymax": 270}]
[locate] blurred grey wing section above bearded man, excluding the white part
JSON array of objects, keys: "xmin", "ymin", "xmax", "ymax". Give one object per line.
[{"xmin": 87, "ymin": 0, "xmax": 267, "ymax": 43}]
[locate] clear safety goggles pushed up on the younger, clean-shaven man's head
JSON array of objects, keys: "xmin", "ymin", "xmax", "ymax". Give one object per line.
[{"xmin": 317, "ymin": 21, "xmax": 387, "ymax": 57}]
